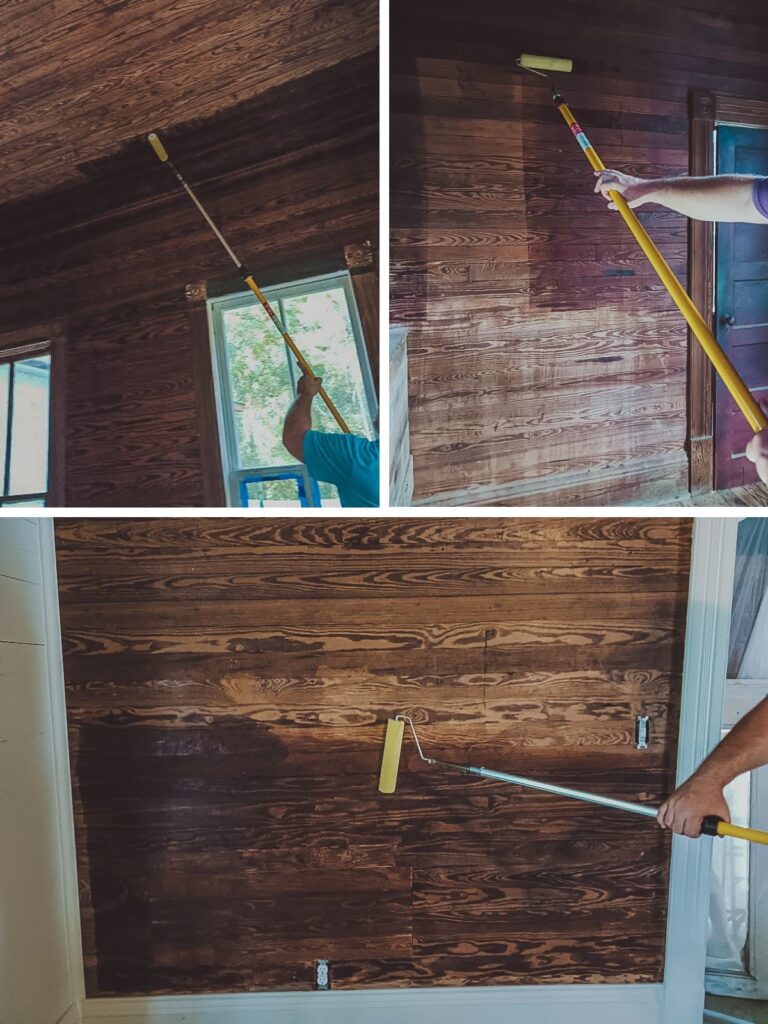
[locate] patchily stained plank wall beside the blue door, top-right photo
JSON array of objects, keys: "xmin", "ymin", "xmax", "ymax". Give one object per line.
[{"xmin": 391, "ymin": 0, "xmax": 768, "ymax": 505}]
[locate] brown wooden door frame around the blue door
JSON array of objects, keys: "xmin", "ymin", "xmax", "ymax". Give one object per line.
[{"xmin": 688, "ymin": 89, "xmax": 768, "ymax": 495}]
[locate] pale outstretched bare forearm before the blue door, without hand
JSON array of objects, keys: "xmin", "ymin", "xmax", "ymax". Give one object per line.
[{"xmin": 635, "ymin": 174, "xmax": 761, "ymax": 222}]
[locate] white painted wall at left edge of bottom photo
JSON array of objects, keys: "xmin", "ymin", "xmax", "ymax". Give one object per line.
[{"xmin": 0, "ymin": 518, "xmax": 75, "ymax": 1024}]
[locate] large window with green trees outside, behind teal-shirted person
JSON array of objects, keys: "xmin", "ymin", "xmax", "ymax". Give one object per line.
[{"xmin": 208, "ymin": 271, "xmax": 376, "ymax": 508}]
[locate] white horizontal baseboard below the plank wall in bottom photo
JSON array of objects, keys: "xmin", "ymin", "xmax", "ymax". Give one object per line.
[{"xmin": 83, "ymin": 985, "xmax": 664, "ymax": 1024}]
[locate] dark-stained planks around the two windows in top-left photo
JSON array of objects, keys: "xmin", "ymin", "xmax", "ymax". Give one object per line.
[{"xmin": 0, "ymin": 51, "xmax": 379, "ymax": 507}]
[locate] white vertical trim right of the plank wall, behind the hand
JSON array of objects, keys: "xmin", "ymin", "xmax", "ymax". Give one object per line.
[{"xmin": 663, "ymin": 517, "xmax": 738, "ymax": 1024}]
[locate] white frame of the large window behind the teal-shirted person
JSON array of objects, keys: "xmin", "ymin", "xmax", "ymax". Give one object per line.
[{"xmin": 206, "ymin": 270, "xmax": 378, "ymax": 508}]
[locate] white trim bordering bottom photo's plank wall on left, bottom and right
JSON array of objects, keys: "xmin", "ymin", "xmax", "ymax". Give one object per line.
[{"xmin": 39, "ymin": 520, "xmax": 740, "ymax": 1024}]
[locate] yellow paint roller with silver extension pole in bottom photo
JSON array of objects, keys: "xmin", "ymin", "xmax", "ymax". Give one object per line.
[{"xmin": 379, "ymin": 715, "xmax": 768, "ymax": 846}]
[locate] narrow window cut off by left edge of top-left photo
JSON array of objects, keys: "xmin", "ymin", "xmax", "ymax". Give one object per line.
[{"xmin": 0, "ymin": 342, "xmax": 51, "ymax": 508}]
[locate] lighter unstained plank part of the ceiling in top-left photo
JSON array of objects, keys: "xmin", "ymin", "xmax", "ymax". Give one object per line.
[{"xmin": 0, "ymin": 0, "xmax": 378, "ymax": 204}]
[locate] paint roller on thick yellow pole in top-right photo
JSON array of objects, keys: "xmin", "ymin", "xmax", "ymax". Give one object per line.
[{"xmin": 517, "ymin": 53, "xmax": 768, "ymax": 433}]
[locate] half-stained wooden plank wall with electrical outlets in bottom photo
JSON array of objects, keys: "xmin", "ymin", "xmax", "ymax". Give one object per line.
[{"xmin": 56, "ymin": 518, "xmax": 690, "ymax": 995}]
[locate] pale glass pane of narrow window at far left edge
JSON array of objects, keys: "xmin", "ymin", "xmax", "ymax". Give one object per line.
[{"xmin": 9, "ymin": 355, "xmax": 50, "ymax": 495}]
